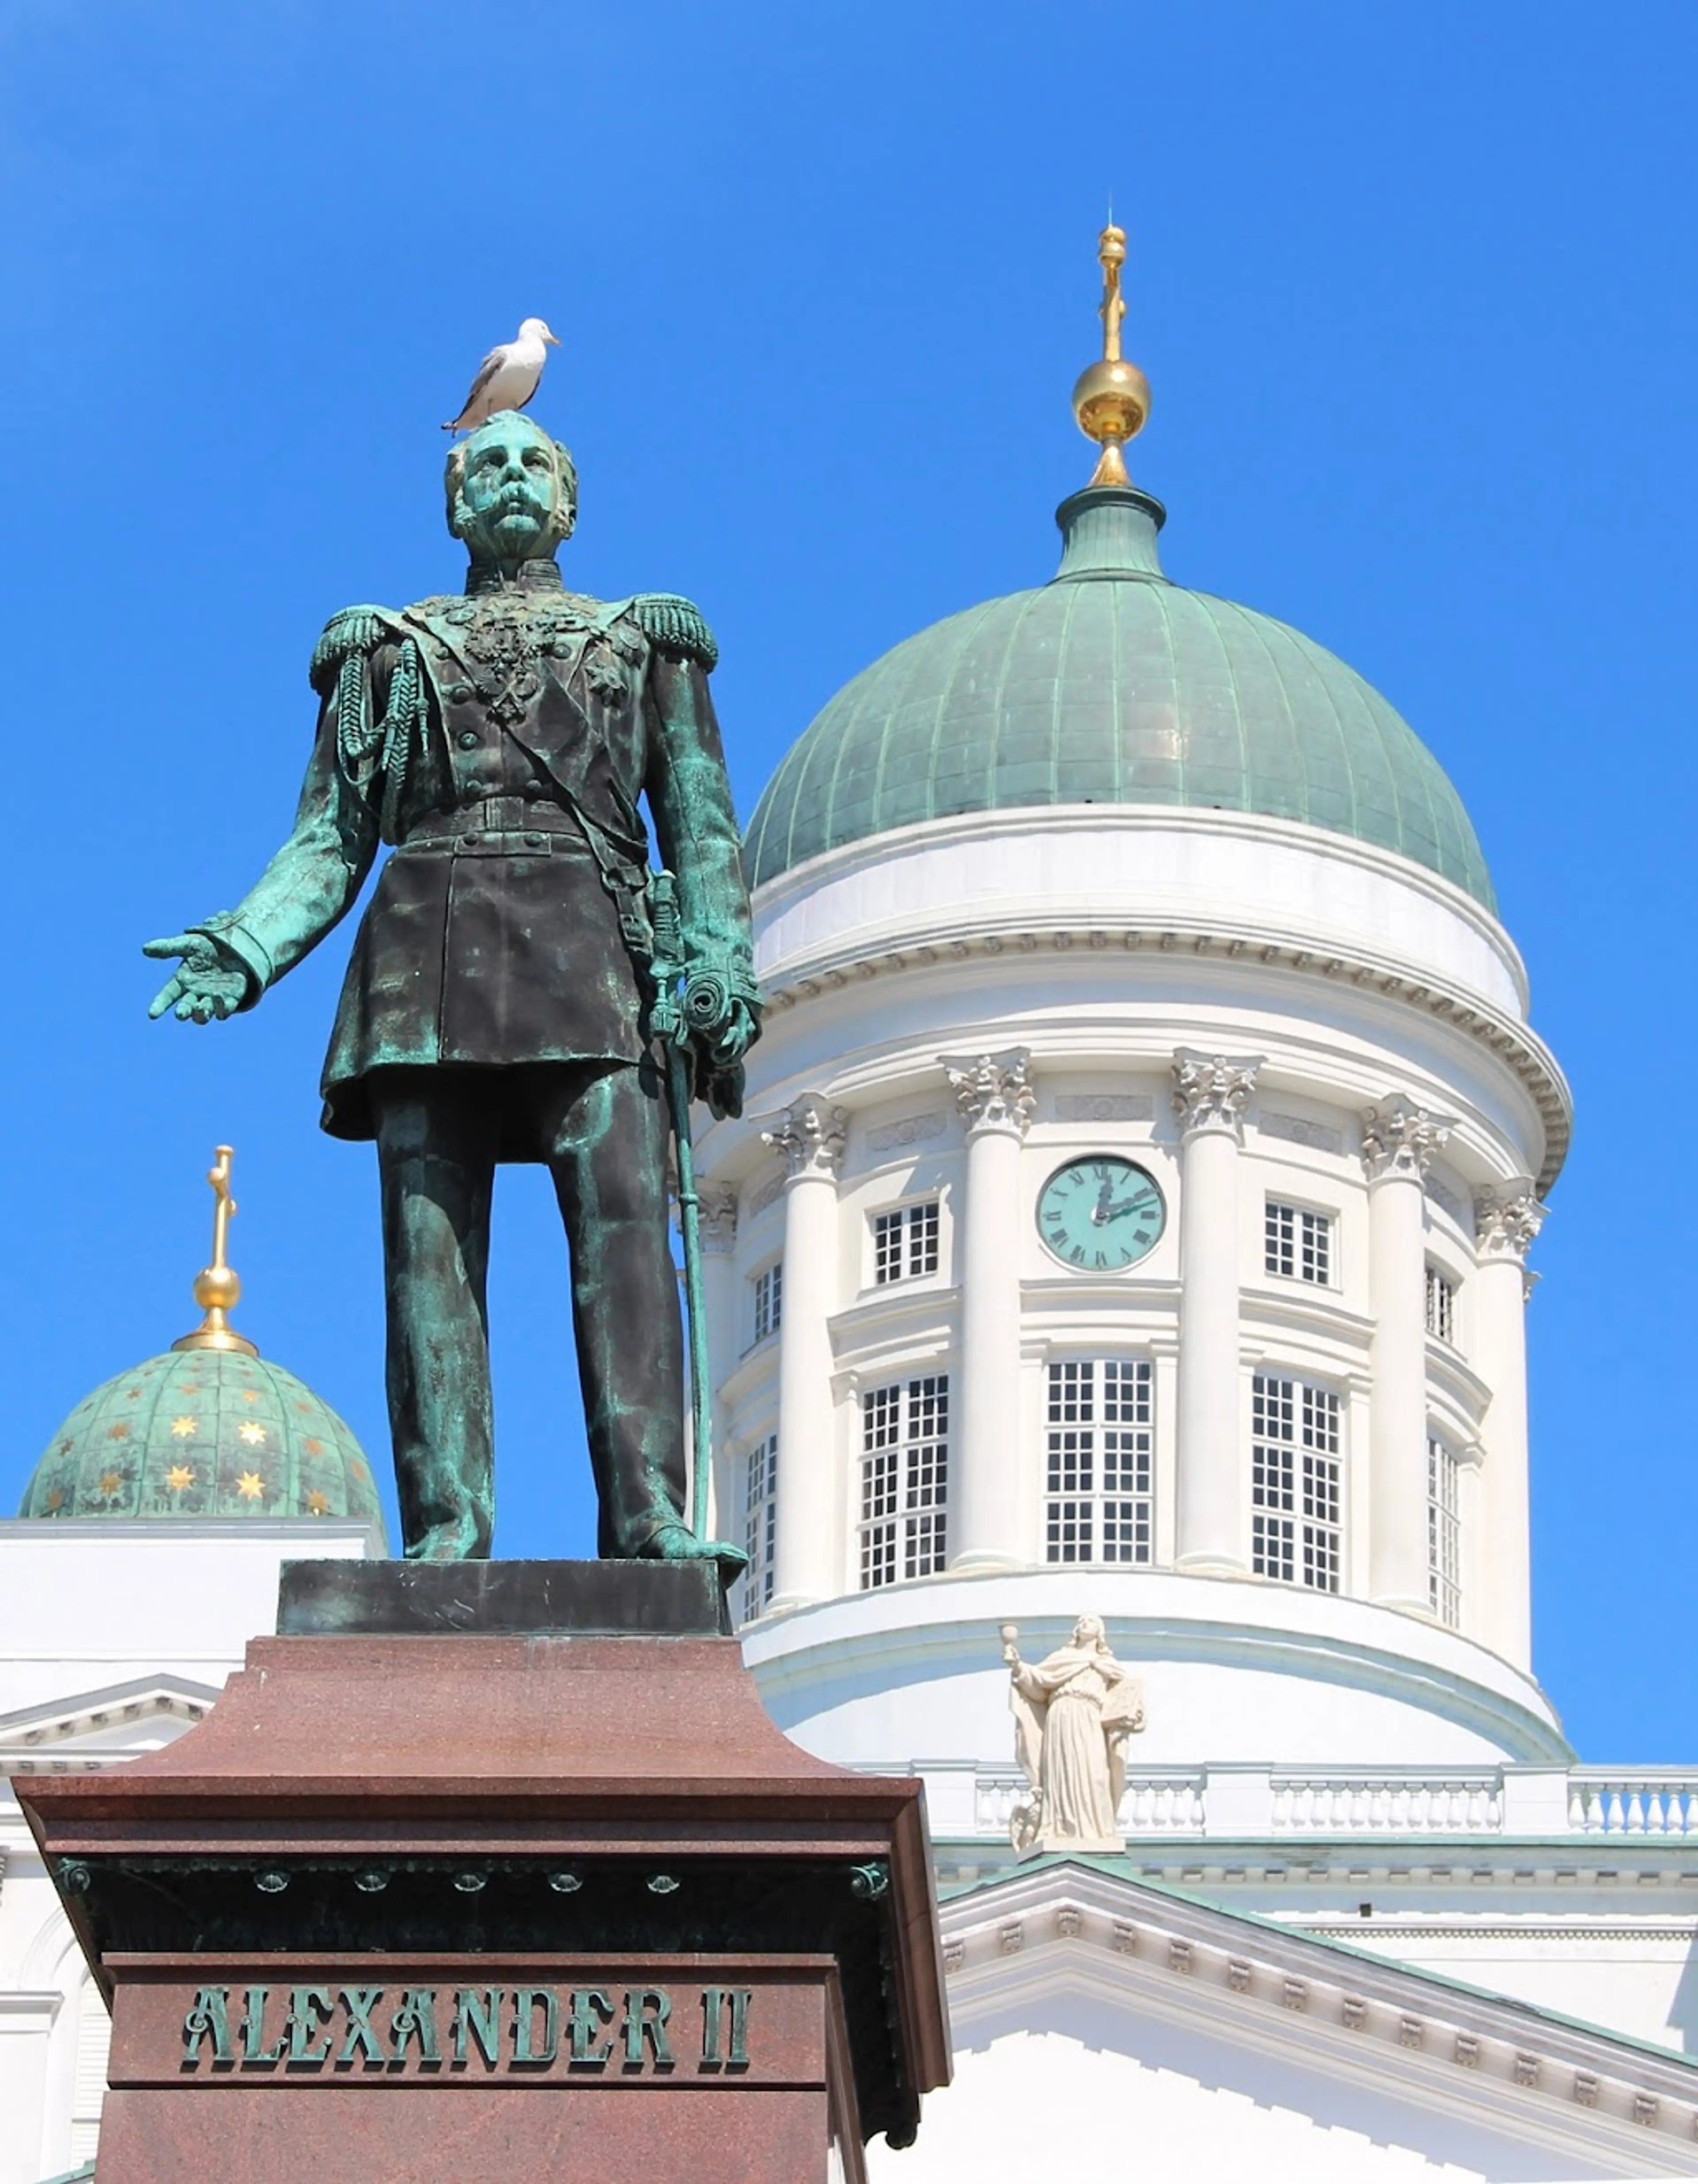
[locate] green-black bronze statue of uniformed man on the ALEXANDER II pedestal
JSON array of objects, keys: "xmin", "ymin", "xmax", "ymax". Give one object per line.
[{"xmin": 146, "ymin": 411, "xmax": 758, "ymax": 1566}]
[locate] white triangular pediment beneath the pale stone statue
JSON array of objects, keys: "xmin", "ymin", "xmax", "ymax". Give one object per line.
[{"xmin": 935, "ymin": 1861, "xmax": 1698, "ymax": 2184}]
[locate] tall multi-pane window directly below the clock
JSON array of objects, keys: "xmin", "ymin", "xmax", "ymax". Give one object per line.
[{"xmin": 1044, "ymin": 1358, "xmax": 1156, "ymax": 1561}]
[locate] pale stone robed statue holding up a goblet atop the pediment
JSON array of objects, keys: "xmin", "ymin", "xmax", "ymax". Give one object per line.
[{"xmin": 1003, "ymin": 1616, "xmax": 1143, "ymax": 1856}]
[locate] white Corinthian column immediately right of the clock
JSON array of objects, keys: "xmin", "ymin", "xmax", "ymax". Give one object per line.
[{"xmin": 1174, "ymin": 1046, "xmax": 1263, "ymax": 1575}]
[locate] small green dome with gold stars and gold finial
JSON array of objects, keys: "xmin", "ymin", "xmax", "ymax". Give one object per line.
[{"xmin": 18, "ymin": 1147, "xmax": 382, "ymax": 1535}]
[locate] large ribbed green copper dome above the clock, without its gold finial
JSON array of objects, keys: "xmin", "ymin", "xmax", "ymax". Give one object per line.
[{"xmin": 747, "ymin": 487, "xmax": 1497, "ymax": 909}]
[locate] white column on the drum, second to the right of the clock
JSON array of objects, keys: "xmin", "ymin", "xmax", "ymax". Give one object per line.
[{"xmin": 1350, "ymin": 1096, "xmax": 1451, "ymax": 1616}]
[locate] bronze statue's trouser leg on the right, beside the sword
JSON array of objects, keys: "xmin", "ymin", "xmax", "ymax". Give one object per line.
[{"xmin": 537, "ymin": 1063, "xmax": 686, "ymax": 1555}]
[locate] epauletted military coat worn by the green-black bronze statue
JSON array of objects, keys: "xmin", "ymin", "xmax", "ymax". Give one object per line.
[{"xmin": 195, "ymin": 561, "xmax": 756, "ymax": 1158}]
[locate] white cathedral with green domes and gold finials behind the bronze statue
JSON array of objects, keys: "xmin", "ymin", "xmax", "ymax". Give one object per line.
[{"xmin": 0, "ymin": 243, "xmax": 1698, "ymax": 2184}]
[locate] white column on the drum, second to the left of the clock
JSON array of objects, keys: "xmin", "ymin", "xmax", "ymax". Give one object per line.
[{"xmin": 761, "ymin": 1094, "xmax": 848, "ymax": 1610}]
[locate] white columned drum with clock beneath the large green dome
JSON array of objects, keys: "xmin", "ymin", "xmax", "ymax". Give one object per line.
[{"xmin": 701, "ymin": 810, "xmax": 1567, "ymax": 1758}]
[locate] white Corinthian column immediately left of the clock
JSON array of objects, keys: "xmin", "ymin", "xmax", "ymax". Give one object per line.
[{"xmin": 940, "ymin": 1046, "xmax": 1038, "ymax": 1570}]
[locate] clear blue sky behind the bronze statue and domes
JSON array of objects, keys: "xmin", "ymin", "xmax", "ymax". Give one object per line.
[{"xmin": 0, "ymin": 0, "xmax": 1698, "ymax": 1763}]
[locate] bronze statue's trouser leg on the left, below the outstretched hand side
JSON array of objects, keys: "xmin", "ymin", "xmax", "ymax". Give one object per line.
[{"xmin": 376, "ymin": 1086, "xmax": 496, "ymax": 1561}]
